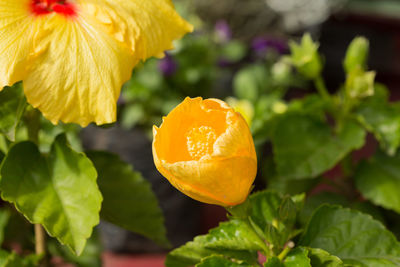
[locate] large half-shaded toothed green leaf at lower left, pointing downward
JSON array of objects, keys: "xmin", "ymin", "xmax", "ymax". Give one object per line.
[{"xmin": 0, "ymin": 135, "xmax": 102, "ymax": 254}]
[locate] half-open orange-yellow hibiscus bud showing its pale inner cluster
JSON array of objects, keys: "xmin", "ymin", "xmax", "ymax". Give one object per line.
[{"xmin": 153, "ymin": 97, "xmax": 257, "ymax": 206}]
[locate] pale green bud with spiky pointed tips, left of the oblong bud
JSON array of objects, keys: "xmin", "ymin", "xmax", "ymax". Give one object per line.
[{"xmin": 289, "ymin": 33, "xmax": 322, "ymax": 79}]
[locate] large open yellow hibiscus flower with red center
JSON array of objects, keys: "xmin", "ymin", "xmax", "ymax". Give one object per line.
[{"xmin": 0, "ymin": 0, "xmax": 192, "ymax": 126}]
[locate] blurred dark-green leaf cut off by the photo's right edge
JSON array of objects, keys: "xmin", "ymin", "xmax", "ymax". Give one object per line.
[{"xmin": 354, "ymin": 152, "xmax": 400, "ymax": 213}]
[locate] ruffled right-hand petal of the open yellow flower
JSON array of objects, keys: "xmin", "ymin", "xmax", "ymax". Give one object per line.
[{"xmin": 78, "ymin": 0, "xmax": 193, "ymax": 60}]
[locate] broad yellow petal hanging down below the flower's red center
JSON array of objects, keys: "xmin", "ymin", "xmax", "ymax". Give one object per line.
[{"xmin": 24, "ymin": 14, "xmax": 138, "ymax": 126}]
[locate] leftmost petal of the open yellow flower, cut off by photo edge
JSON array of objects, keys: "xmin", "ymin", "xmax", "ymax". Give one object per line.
[{"xmin": 0, "ymin": 0, "xmax": 38, "ymax": 91}]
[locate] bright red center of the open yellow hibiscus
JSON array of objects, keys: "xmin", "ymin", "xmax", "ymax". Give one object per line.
[{"xmin": 31, "ymin": 0, "xmax": 76, "ymax": 17}]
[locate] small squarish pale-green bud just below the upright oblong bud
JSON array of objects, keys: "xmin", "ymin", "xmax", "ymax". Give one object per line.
[{"xmin": 346, "ymin": 69, "xmax": 376, "ymax": 98}]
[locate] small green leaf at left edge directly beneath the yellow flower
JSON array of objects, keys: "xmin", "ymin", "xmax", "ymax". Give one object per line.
[{"xmin": 0, "ymin": 83, "xmax": 27, "ymax": 141}]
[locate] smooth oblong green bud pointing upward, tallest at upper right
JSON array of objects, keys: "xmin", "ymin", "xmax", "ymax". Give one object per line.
[{"xmin": 343, "ymin": 37, "xmax": 369, "ymax": 73}]
